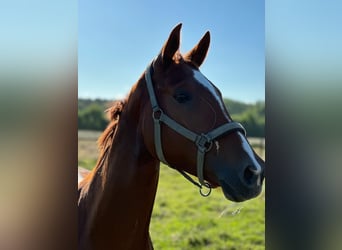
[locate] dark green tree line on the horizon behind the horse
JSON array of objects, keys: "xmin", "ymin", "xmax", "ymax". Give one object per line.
[{"xmin": 78, "ymin": 98, "xmax": 265, "ymax": 137}]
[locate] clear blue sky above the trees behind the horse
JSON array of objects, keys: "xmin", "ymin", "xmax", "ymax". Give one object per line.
[{"xmin": 78, "ymin": 0, "xmax": 265, "ymax": 102}]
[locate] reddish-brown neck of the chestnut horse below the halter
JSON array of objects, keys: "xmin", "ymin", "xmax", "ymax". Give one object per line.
[{"xmin": 83, "ymin": 78, "xmax": 159, "ymax": 249}]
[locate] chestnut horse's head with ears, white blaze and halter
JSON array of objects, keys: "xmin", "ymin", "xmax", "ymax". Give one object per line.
[{"xmin": 142, "ymin": 24, "xmax": 264, "ymax": 202}]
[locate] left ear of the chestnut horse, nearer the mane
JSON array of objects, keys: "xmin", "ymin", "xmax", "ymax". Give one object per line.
[{"xmin": 160, "ymin": 23, "xmax": 182, "ymax": 66}]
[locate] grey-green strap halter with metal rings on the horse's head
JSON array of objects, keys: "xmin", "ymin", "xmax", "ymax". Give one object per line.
[{"xmin": 145, "ymin": 62, "xmax": 246, "ymax": 196}]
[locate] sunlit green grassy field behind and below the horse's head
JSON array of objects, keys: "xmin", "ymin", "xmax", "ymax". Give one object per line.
[{"xmin": 78, "ymin": 131, "xmax": 265, "ymax": 250}]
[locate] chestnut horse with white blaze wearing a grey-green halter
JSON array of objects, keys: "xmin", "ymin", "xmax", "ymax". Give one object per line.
[{"xmin": 78, "ymin": 24, "xmax": 264, "ymax": 250}]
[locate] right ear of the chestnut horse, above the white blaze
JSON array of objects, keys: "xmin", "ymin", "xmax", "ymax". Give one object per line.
[{"xmin": 184, "ymin": 31, "xmax": 210, "ymax": 68}]
